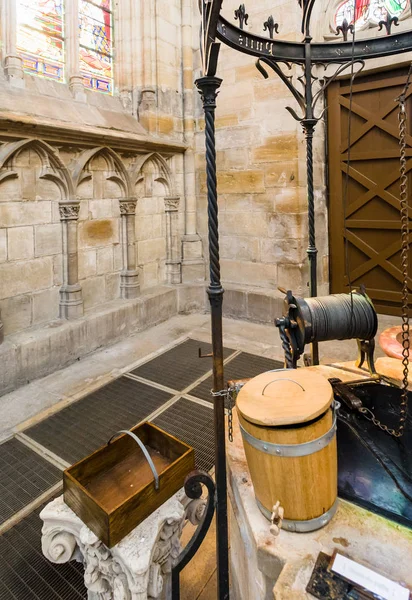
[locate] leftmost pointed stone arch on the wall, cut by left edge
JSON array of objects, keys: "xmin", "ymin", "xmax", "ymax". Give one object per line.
[{"xmin": 0, "ymin": 138, "xmax": 74, "ymax": 200}]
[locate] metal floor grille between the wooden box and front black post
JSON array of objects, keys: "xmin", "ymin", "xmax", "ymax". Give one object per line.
[{"xmin": 154, "ymin": 398, "xmax": 215, "ymax": 471}]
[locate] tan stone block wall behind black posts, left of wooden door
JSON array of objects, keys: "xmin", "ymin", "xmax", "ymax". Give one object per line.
[{"xmin": 196, "ymin": 0, "xmax": 327, "ymax": 300}]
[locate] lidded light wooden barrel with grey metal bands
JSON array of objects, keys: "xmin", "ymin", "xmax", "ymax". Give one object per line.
[{"xmin": 236, "ymin": 368, "xmax": 337, "ymax": 532}]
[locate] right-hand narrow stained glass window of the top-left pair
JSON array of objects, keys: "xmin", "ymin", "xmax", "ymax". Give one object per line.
[{"xmin": 79, "ymin": 0, "xmax": 113, "ymax": 94}]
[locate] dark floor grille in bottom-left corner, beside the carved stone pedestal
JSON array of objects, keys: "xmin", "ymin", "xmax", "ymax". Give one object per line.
[{"xmin": 0, "ymin": 506, "xmax": 87, "ymax": 600}]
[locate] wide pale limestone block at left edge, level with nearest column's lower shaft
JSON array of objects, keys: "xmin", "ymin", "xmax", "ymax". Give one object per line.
[{"xmin": 0, "ymin": 256, "xmax": 53, "ymax": 298}]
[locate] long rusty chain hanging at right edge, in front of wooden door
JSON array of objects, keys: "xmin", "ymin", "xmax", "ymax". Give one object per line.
[{"xmin": 359, "ymin": 63, "xmax": 412, "ymax": 438}]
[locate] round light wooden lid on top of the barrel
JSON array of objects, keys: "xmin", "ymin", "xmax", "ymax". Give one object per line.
[{"xmin": 236, "ymin": 368, "xmax": 333, "ymax": 427}]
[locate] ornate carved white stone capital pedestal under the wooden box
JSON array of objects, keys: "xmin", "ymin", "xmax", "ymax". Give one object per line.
[{"xmin": 40, "ymin": 492, "xmax": 205, "ymax": 600}]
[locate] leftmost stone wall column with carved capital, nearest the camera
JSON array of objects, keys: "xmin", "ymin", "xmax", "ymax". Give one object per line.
[{"xmin": 59, "ymin": 201, "xmax": 84, "ymax": 319}]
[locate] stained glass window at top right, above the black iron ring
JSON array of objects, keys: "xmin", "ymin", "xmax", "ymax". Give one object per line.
[{"xmin": 335, "ymin": 0, "xmax": 407, "ymax": 29}]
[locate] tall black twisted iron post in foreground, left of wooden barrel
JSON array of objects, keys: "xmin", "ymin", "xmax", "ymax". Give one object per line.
[{"xmin": 196, "ymin": 76, "xmax": 229, "ymax": 600}]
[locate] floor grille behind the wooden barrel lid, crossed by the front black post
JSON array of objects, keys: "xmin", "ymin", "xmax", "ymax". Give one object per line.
[{"xmin": 188, "ymin": 352, "xmax": 284, "ymax": 402}]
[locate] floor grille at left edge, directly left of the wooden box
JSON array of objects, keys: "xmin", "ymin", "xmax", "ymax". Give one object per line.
[{"xmin": 0, "ymin": 439, "xmax": 61, "ymax": 525}]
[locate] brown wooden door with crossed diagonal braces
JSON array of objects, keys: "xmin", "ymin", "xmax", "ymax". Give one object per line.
[{"xmin": 327, "ymin": 70, "xmax": 412, "ymax": 315}]
